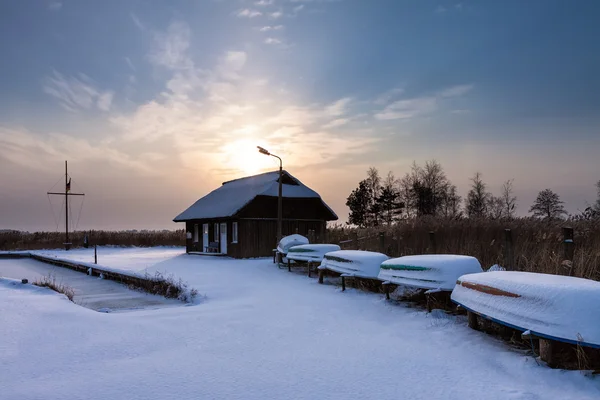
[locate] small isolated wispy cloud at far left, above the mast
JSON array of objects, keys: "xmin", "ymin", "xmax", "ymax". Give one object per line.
[{"xmin": 43, "ymin": 71, "xmax": 113, "ymax": 112}]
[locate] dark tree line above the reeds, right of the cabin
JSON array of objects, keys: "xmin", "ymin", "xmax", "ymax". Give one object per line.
[{"xmin": 346, "ymin": 160, "xmax": 600, "ymax": 227}]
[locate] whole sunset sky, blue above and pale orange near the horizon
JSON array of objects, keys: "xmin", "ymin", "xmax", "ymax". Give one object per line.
[{"xmin": 0, "ymin": 0, "xmax": 600, "ymax": 231}]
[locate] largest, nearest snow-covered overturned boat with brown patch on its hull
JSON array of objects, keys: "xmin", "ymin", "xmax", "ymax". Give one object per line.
[{"xmin": 452, "ymin": 271, "xmax": 600, "ymax": 348}]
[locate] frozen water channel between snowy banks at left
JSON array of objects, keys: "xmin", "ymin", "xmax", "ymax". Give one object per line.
[{"xmin": 0, "ymin": 258, "xmax": 183, "ymax": 312}]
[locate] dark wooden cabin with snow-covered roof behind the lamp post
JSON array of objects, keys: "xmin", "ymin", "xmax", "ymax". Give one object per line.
[{"xmin": 173, "ymin": 171, "xmax": 338, "ymax": 258}]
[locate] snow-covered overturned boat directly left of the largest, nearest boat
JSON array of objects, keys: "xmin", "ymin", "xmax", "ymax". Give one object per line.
[{"xmin": 378, "ymin": 254, "xmax": 482, "ymax": 291}]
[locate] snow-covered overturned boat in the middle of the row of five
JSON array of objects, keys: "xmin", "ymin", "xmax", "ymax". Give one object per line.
[{"xmin": 319, "ymin": 250, "xmax": 389, "ymax": 279}]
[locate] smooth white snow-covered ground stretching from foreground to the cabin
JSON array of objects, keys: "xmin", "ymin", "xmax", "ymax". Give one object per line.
[{"xmin": 0, "ymin": 249, "xmax": 600, "ymax": 400}]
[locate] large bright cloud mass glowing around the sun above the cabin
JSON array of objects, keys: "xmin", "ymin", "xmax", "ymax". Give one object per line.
[{"xmin": 109, "ymin": 22, "xmax": 373, "ymax": 180}]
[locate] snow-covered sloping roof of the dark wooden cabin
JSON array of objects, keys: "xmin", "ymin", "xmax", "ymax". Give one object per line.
[{"xmin": 173, "ymin": 171, "xmax": 337, "ymax": 222}]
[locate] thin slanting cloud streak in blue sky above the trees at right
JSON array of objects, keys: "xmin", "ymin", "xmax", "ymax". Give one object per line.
[{"xmin": 375, "ymin": 85, "xmax": 473, "ymax": 120}]
